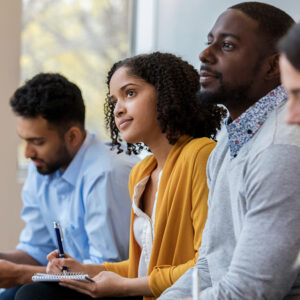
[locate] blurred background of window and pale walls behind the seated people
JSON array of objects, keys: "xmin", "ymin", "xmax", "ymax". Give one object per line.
[{"xmin": 0, "ymin": 0, "xmax": 300, "ymax": 251}]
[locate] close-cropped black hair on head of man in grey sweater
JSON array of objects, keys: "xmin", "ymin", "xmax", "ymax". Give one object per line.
[{"xmin": 229, "ymin": 2, "xmax": 295, "ymax": 53}]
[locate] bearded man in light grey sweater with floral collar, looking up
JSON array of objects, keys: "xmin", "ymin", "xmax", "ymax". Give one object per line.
[{"xmin": 159, "ymin": 2, "xmax": 300, "ymax": 300}]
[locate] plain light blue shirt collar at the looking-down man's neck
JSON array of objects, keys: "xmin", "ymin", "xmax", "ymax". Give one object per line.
[{"xmin": 59, "ymin": 132, "xmax": 93, "ymax": 186}]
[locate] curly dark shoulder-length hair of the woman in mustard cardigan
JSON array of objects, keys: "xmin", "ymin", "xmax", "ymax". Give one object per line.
[{"xmin": 104, "ymin": 52, "xmax": 226, "ymax": 154}]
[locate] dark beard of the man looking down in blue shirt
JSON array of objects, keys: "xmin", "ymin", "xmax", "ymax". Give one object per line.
[{"xmin": 33, "ymin": 144, "xmax": 73, "ymax": 175}]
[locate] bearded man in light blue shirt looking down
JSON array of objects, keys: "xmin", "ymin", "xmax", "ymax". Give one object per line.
[{"xmin": 0, "ymin": 73, "xmax": 136, "ymax": 300}]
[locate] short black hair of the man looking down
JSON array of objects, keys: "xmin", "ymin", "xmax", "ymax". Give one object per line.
[{"xmin": 10, "ymin": 73, "xmax": 85, "ymax": 133}]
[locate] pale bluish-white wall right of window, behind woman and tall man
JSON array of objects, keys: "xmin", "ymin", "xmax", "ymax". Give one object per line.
[{"xmin": 135, "ymin": 0, "xmax": 300, "ymax": 68}]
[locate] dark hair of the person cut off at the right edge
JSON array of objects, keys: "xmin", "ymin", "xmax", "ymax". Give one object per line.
[{"xmin": 279, "ymin": 23, "xmax": 300, "ymax": 71}]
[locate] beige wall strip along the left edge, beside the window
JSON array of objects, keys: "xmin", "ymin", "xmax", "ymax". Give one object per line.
[{"xmin": 0, "ymin": 0, "xmax": 23, "ymax": 251}]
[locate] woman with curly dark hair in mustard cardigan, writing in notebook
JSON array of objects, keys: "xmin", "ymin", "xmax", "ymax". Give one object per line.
[{"xmin": 16, "ymin": 52, "xmax": 225, "ymax": 300}]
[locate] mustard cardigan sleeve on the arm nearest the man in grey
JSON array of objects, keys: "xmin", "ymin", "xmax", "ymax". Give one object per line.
[{"xmin": 149, "ymin": 141, "xmax": 215, "ymax": 298}]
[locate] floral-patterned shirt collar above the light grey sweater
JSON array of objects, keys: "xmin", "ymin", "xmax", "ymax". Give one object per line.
[{"xmin": 225, "ymin": 85, "xmax": 287, "ymax": 159}]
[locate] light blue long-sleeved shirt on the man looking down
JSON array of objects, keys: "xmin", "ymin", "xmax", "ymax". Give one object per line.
[{"xmin": 17, "ymin": 134, "xmax": 137, "ymax": 265}]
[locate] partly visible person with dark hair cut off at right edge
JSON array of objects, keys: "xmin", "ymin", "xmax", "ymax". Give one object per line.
[{"xmin": 279, "ymin": 23, "xmax": 300, "ymax": 126}]
